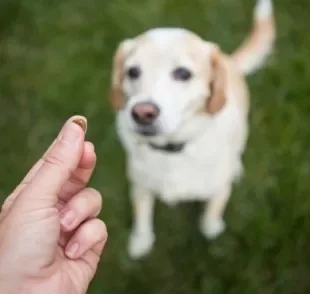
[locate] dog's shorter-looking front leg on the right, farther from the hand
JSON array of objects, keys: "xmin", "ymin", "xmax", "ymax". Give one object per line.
[{"xmin": 200, "ymin": 184, "xmax": 231, "ymax": 239}]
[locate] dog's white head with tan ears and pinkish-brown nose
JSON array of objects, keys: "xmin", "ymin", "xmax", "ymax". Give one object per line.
[{"xmin": 111, "ymin": 29, "xmax": 226, "ymax": 142}]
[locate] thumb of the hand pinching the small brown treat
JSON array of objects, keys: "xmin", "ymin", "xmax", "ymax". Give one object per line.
[{"xmin": 18, "ymin": 117, "xmax": 86, "ymax": 210}]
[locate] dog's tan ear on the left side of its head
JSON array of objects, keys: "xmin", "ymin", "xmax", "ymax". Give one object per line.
[{"xmin": 110, "ymin": 39, "xmax": 134, "ymax": 110}]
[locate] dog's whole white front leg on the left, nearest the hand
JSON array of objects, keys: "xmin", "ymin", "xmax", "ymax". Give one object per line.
[{"xmin": 128, "ymin": 185, "xmax": 155, "ymax": 259}]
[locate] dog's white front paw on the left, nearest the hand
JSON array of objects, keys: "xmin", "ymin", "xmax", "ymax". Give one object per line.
[{"xmin": 128, "ymin": 233, "xmax": 155, "ymax": 259}]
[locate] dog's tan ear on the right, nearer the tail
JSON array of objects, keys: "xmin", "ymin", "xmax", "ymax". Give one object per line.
[{"xmin": 206, "ymin": 46, "xmax": 227, "ymax": 114}]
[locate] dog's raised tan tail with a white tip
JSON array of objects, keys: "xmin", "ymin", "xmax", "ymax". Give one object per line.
[{"xmin": 231, "ymin": 0, "xmax": 276, "ymax": 75}]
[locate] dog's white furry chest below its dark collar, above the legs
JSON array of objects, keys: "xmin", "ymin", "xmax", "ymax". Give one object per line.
[{"xmin": 129, "ymin": 134, "xmax": 229, "ymax": 202}]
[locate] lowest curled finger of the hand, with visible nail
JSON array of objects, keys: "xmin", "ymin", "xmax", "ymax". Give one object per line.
[{"xmin": 65, "ymin": 219, "xmax": 108, "ymax": 259}]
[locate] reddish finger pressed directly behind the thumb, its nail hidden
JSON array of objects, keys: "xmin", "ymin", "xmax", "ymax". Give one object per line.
[{"xmin": 59, "ymin": 142, "xmax": 97, "ymax": 202}]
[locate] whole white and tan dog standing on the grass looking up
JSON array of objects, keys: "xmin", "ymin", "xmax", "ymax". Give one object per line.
[{"xmin": 111, "ymin": 0, "xmax": 275, "ymax": 258}]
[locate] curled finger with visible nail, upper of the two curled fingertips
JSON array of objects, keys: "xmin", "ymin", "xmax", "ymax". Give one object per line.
[{"xmin": 60, "ymin": 188, "xmax": 102, "ymax": 232}]
